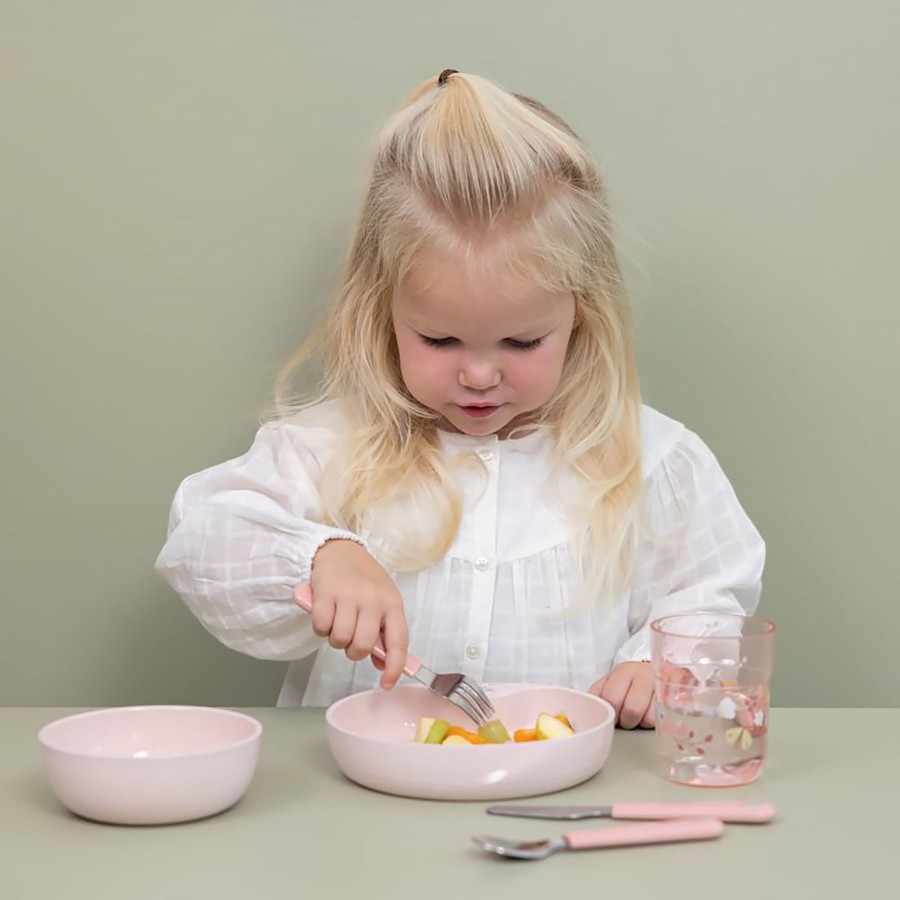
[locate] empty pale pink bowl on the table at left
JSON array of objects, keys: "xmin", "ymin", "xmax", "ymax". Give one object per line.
[{"xmin": 38, "ymin": 706, "xmax": 262, "ymax": 825}]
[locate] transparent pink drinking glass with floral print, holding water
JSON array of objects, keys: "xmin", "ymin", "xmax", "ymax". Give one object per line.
[{"xmin": 650, "ymin": 613, "xmax": 775, "ymax": 787}]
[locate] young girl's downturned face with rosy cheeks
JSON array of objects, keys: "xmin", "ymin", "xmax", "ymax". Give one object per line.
[{"xmin": 392, "ymin": 250, "xmax": 575, "ymax": 435}]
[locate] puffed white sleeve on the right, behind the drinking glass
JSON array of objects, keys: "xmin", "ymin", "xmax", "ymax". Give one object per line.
[{"xmin": 614, "ymin": 420, "xmax": 765, "ymax": 664}]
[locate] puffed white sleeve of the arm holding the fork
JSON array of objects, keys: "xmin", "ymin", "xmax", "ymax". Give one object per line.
[{"xmin": 156, "ymin": 414, "xmax": 360, "ymax": 660}]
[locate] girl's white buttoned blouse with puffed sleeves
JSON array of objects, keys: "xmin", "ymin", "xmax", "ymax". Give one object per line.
[{"xmin": 156, "ymin": 403, "xmax": 765, "ymax": 706}]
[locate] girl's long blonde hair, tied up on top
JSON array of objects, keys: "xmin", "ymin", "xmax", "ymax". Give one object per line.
[{"xmin": 276, "ymin": 71, "xmax": 642, "ymax": 590}]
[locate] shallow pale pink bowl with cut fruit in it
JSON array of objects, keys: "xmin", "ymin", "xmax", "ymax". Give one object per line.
[{"xmin": 325, "ymin": 684, "xmax": 615, "ymax": 800}]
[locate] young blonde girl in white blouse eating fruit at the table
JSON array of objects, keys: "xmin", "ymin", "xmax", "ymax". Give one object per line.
[{"xmin": 157, "ymin": 70, "xmax": 764, "ymax": 728}]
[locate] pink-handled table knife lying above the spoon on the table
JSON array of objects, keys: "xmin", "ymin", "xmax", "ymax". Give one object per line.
[{"xmin": 487, "ymin": 801, "xmax": 775, "ymax": 825}]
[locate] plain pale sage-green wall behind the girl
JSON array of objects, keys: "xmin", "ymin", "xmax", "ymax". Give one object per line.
[{"xmin": 0, "ymin": 0, "xmax": 900, "ymax": 706}]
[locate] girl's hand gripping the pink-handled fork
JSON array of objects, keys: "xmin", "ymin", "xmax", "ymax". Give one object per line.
[{"xmin": 310, "ymin": 540, "xmax": 409, "ymax": 690}]
